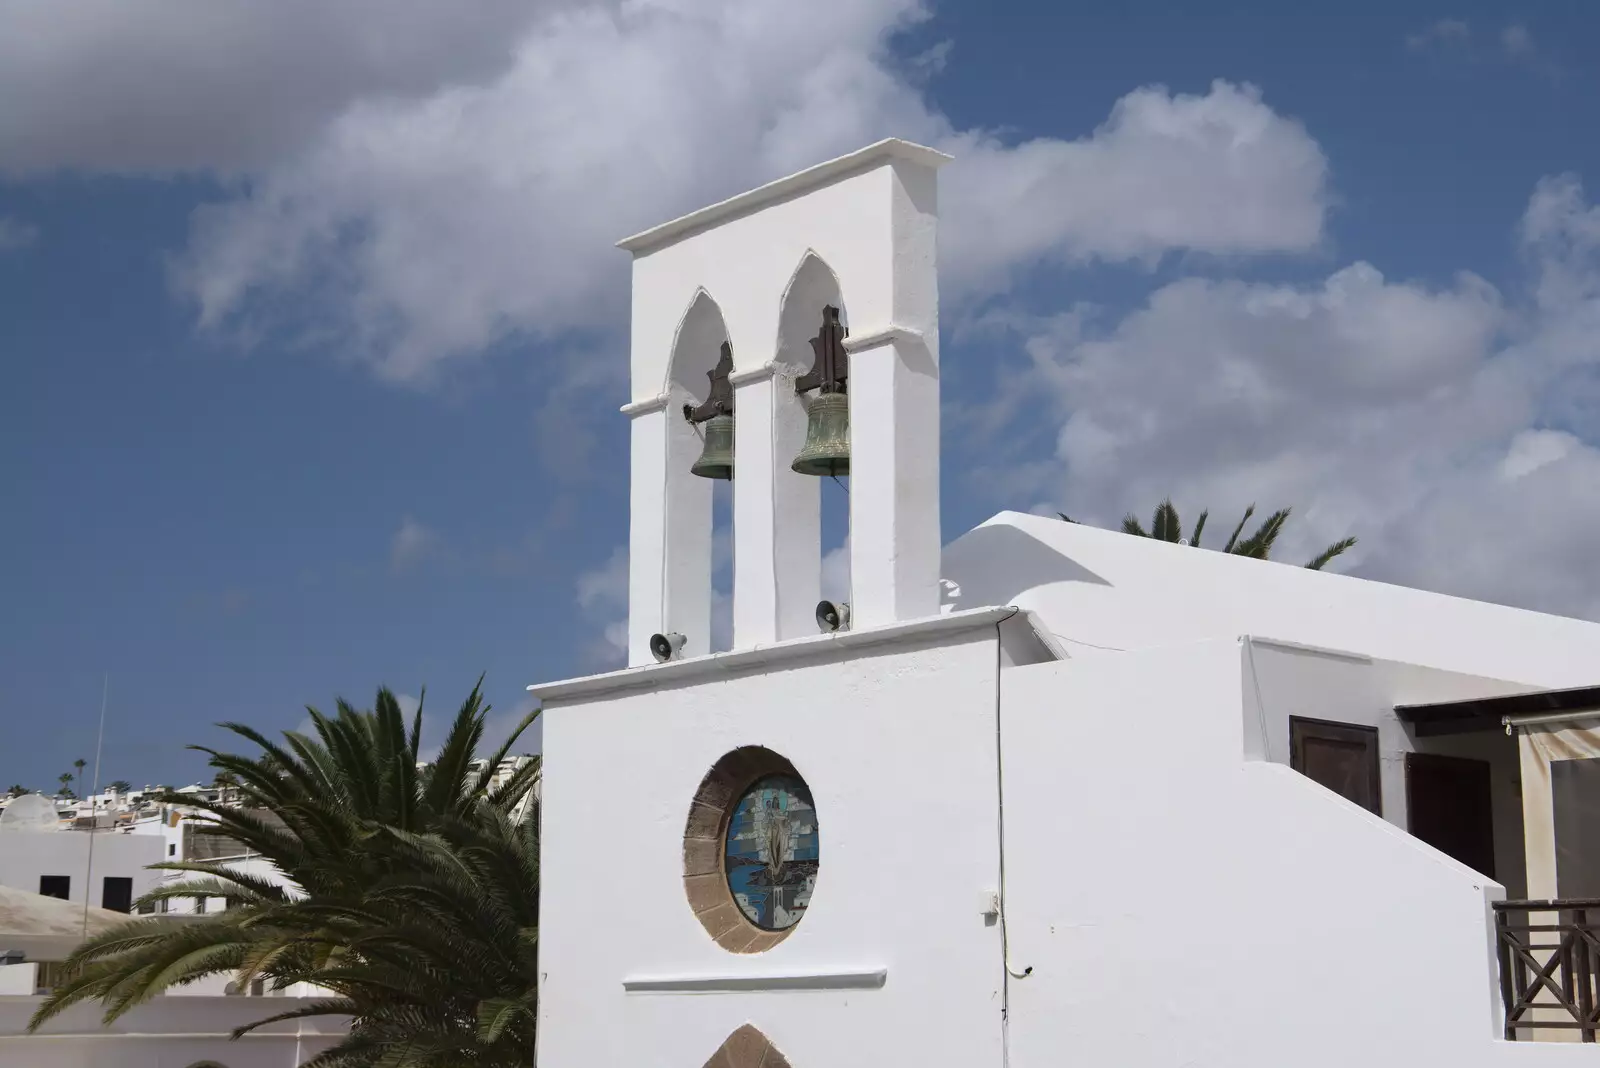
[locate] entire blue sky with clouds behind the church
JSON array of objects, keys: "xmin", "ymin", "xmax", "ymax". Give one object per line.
[{"xmin": 0, "ymin": 0, "xmax": 1600, "ymax": 787}]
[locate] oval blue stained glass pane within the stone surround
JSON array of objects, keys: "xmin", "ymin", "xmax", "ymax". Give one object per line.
[{"xmin": 723, "ymin": 775, "xmax": 818, "ymax": 931}]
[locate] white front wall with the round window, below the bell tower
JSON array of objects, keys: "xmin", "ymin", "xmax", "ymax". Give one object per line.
[{"xmin": 539, "ymin": 625, "xmax": 1000, "ymax": 1068}]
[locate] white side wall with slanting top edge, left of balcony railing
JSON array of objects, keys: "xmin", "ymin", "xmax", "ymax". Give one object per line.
[{"xmin": 998, "ymin": 641, "xmax": 1594, "ymax": 1068}]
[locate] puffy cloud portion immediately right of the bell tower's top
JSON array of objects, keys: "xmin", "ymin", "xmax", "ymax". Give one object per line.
[{"xmin": 939, "ymin": 82, "xmax": 1328, "ymax": 293}]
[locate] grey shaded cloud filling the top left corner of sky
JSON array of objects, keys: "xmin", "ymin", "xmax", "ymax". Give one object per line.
[{"xmin": 0, "ymin": 0, "xmax": 537, "ymax": 174}]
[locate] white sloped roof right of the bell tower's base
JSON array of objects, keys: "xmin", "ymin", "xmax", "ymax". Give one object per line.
[{"xmin": 942, "ymin": 512, "xmax": 1600, "ymax": 687}]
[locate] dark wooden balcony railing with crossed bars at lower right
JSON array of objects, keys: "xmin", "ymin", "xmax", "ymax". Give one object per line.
[{"xmin": 1494, "ymin": 899, "xmax": 1600, "ymax": 1042}]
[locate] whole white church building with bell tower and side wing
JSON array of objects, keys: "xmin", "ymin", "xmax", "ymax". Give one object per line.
[{"xmin": 530, "ymin": 141, "xmax": 1600, "ymax": 1068}]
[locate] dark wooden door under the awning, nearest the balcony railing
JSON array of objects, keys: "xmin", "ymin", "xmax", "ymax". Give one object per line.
[{"xmin": 1405, "ymin": 753, "xmax": 1494, "ymax": 879}]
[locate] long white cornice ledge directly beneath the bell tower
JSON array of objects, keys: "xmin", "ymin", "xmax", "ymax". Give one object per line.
[{"xmin": 528, "ymin": 606, "xmax": 1048, "ymax": 703}]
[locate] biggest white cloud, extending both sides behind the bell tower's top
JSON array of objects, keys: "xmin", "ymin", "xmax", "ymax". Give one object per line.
[{"xmin": 140, "ymin": 0, "xmax": 1326, "ymax": 381}]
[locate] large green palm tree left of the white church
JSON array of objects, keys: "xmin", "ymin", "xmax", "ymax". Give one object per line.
[{"xmin": 30, "ymin": 687, "xmax": 539, "ymax": 1068}]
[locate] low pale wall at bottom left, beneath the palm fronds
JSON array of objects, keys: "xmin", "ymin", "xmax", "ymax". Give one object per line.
[{"xmin": 0, "ymin": 996, "xmax": 346, "ymax": 1068}]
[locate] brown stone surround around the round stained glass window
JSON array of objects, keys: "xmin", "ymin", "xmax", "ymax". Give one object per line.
[{"xmin": 683, "ymin": 745, "xmax": 805, "ymax": 952}]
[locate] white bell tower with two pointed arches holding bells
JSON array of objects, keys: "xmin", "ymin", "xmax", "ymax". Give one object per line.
[{"xmin": 621, "ymin": 139, "xmax": 950, "ymax": 665}]
